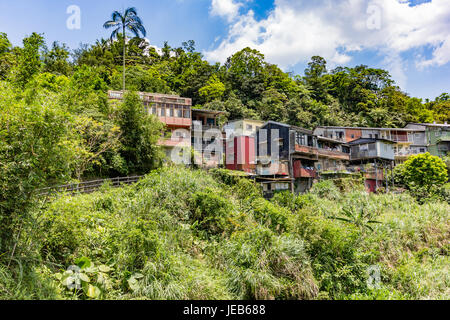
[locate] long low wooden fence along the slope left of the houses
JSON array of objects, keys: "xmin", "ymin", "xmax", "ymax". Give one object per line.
[{"xmin": 38, "ymin": 176, "xmax": 144, "ymax": 196}]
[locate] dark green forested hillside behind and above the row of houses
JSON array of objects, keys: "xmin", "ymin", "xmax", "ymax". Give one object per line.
[{"xmin": 0, "ymin": 34, "xmax": 450, "ymax": 128}]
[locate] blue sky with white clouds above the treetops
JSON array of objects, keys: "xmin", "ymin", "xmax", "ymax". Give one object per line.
[{"xmin": 0, "ymin": 0, "xmax": 450, "ymax": 99}]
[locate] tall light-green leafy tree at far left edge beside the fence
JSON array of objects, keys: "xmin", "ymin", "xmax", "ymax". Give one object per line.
[{"xmin": 0, "ymin": 82, "xmax": 75, "ymax": 256}]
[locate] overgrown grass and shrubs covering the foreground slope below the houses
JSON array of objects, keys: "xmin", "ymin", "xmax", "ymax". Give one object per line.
[{"xmin": 0, "ymin": 167, "xmax": 450, "ymax": 299}]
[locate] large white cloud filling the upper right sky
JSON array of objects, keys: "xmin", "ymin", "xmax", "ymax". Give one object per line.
[{"xmin": 205, "ymin": 0, "xmax": 450, "ymax": 87}]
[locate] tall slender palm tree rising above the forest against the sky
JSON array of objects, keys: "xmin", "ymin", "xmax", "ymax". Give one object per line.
[{"xmin": 103, "ymin": 8, "xmax": 147, "ymax": 91}]
